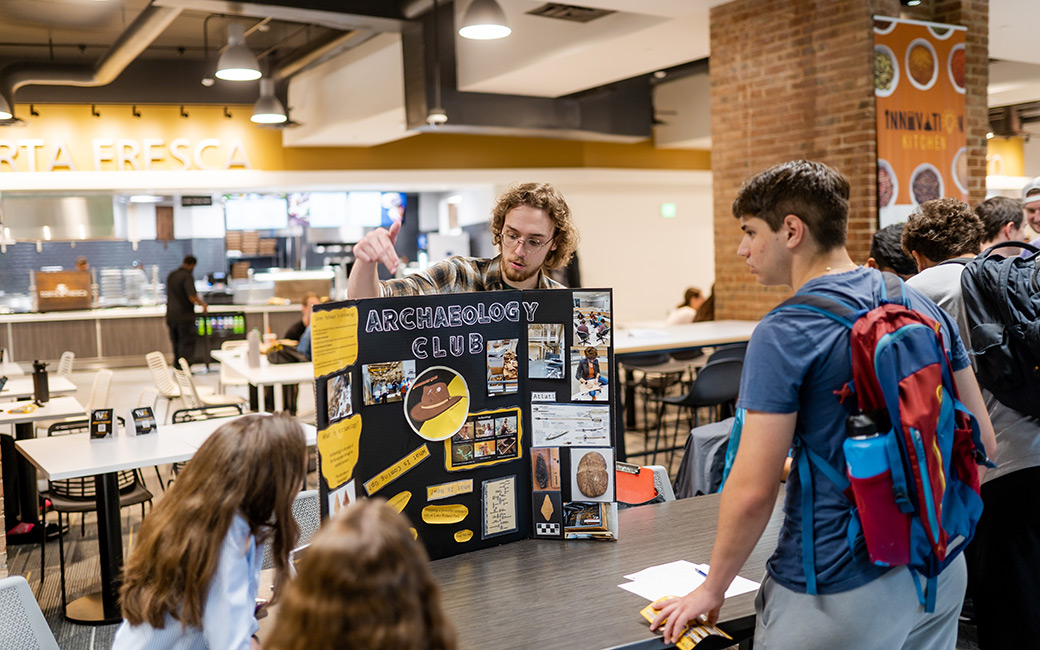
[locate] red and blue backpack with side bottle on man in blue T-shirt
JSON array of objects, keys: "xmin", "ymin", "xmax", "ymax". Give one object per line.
[{"xmin": 774, "ymin": 274, "xmax": 991, "ymax": 612}]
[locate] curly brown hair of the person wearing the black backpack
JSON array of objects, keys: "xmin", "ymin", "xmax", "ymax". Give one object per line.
[{"xmin": 903, "ymin": 199, "xmax": 985, "ymax": 263}]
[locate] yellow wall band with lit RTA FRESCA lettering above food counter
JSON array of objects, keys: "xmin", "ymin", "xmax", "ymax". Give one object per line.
[{"xmin": 0, "ymin": 105, "xmax": 711, "ymax": 174}]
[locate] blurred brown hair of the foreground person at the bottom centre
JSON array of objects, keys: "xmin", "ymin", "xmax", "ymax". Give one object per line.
[{"xmin": 264, "ymin": 499, "xmax": 456, "ymax": 650}]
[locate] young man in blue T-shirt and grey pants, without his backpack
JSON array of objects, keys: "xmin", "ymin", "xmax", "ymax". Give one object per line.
[{"xmin": 651, "ymin": 160, "xmax": 993, "ymax": 650}]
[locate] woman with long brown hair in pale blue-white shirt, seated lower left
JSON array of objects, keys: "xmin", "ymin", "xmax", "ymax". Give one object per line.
[{"xmin": 112, "ymin": 415, "xmax": 307, "ymax": 650}]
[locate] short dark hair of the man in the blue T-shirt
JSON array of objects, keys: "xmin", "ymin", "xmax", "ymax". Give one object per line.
[{"xmin": 733, "ymin": 160, "xmax": 849, "ymax": 251}]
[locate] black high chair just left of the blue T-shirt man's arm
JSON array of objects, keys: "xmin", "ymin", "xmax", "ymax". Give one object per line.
[{"xmin": 650, "ymin": 359, "xmax": 744, "ymax": 467}]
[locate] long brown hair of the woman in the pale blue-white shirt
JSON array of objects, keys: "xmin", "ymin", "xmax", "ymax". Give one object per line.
[{"xmin": 121, "ymin": 415, "xmax": 307, "ymax": 628}]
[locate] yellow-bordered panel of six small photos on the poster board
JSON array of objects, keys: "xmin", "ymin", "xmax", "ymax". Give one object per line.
[{"xmin": 444, "ymin": 407, "xmax": 522, "ymax": 471}]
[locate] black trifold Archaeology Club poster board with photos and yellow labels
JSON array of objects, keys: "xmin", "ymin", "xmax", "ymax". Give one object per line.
[{"xmin": 311, "ymin": 289, "xmax": 618, "ymax": 558}]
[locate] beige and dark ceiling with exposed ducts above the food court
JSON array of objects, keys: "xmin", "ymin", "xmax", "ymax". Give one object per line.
[{"xmin": 0, "ymin": 0, "xmax": 1040, "ymax": 146}]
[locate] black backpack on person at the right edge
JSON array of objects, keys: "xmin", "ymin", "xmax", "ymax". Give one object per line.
[{"xmin": 961, "ymin": 241, "xmax": 1040, "ymax": 417}]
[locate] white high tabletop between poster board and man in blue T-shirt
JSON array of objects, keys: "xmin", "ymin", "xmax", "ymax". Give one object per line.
[{"xmin": 614, "ymin": 320, "xmax": 758, "ymax": 355}]
